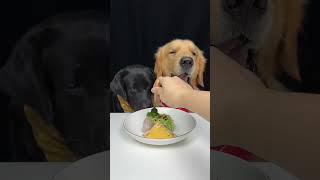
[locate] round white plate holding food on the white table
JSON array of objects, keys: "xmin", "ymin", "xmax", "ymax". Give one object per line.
[{"xmin": 123, "ymin": 107, "xmax": 196, "ymax": 145}]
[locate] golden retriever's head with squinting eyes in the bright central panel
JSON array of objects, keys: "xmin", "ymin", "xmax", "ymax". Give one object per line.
[{"xmin": 154, "ymin": 39, "xmax": 206, "ymax": 89}]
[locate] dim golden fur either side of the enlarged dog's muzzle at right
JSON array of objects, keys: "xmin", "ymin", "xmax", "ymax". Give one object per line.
[{"xmin": 210, "ymin": 0, "xmax": 304, "ymax": 89}]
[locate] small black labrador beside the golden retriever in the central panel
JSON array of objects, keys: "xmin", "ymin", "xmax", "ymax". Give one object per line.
[{"xmin": 110, "ymin": 65, "xmax": 156, "ymax": 112}]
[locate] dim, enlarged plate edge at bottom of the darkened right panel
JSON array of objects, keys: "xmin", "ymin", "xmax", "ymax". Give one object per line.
[{"xmin": 211, "ymin": 151, "xmax": 270, "ymax": 180}]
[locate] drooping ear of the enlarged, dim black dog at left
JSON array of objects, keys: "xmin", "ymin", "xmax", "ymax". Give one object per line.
[{"xmin": 0, "ymin": 29, "xmax": 57, "ymax": 121}]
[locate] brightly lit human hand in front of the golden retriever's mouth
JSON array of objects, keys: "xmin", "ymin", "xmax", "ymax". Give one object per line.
[{"xmin": 151, "ymin": 76, "xmax": 193, "ymax": 108}]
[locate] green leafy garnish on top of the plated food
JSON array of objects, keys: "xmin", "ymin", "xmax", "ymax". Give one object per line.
[{"xmin": 147, "ymin": 107, "xmax": 175, "ymax": 131}]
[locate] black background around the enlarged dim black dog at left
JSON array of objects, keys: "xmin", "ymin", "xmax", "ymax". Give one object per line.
[{"xmin": 0, "ymin": 0, "xmax": 110, "ymax": 161}]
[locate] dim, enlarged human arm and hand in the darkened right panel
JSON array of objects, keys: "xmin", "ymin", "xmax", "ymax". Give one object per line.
[{"xmin": 211, "ymin": 48, "xmax": 320, "ymax": 179}]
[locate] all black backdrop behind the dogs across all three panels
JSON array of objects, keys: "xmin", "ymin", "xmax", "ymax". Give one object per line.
[{"xmin": 0, "ymin": 0, "xmax": 320, "ymax": 160}]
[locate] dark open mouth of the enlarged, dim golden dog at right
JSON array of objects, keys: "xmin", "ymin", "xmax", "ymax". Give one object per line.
[{"xmin": 217, "ymin": 38, "xmax": 248, "ymax": 67}]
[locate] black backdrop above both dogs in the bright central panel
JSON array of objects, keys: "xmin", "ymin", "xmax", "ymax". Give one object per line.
[{"xmin": 110, "ymin": 0, "xmax": 210, "ymax": 90}]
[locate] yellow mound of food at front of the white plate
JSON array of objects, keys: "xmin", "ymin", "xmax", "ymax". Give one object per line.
[{"xmin": 144, "ymin": 123, "xmax": 176, "ymax": 139}]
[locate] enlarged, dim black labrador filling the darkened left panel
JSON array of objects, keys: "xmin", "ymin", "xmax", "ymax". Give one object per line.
[{"xmin": 0, "ymin": 11, "xmax": 110, "ymax": 161}]
